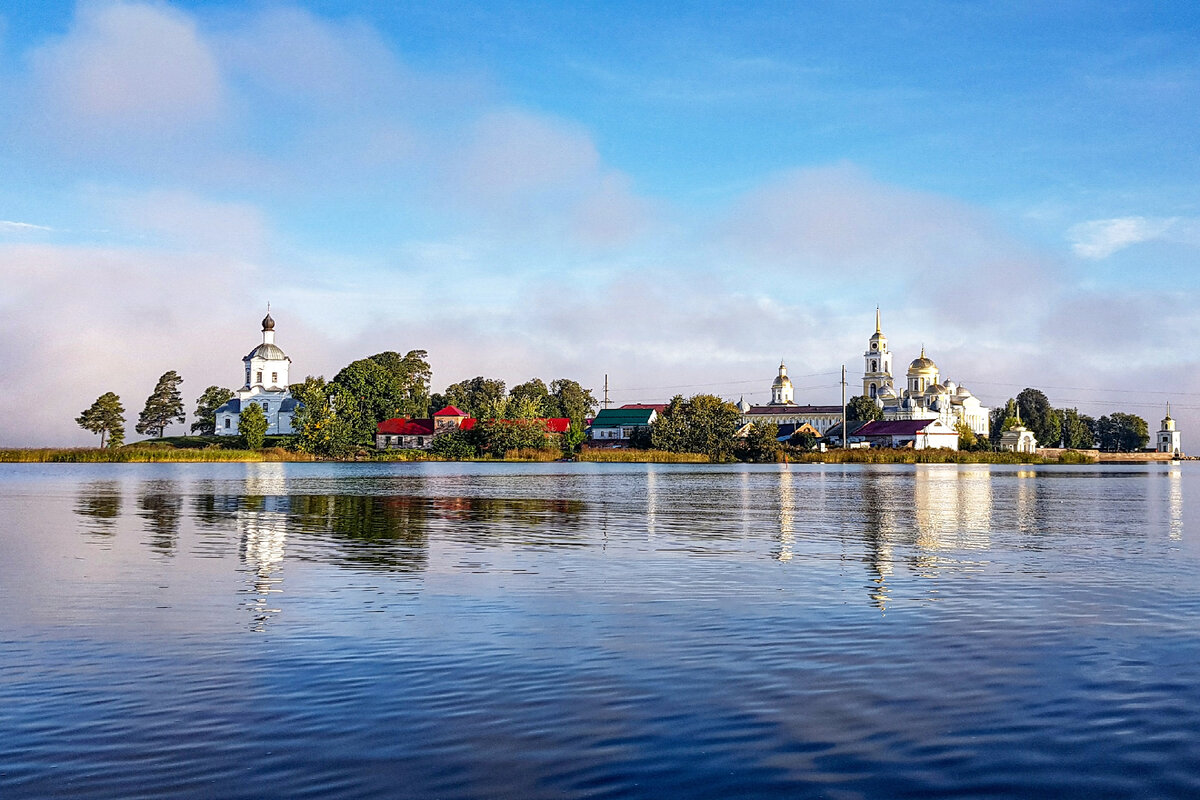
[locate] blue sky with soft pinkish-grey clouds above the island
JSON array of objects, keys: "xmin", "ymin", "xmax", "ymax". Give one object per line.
[{"xmin": 0, "ymin": 0, "xmax": 1200, "ymax": 450}]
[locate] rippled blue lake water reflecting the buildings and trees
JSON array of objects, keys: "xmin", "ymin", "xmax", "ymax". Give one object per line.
[{"xmin": 0, "ymin": 463, "xmax": 1200, "ymax": 799}]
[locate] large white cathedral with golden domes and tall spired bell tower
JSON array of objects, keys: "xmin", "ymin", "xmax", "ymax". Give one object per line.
[{"xmin": 863, "ymin": 308, "xmax": 990, "ymax": 437}]
